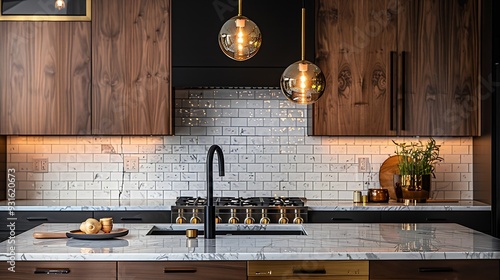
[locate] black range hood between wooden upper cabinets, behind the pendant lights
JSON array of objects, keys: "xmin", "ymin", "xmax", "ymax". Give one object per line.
[{"xmin": 172, "ymin": 0, "xmax": 314, "ymax": 88}]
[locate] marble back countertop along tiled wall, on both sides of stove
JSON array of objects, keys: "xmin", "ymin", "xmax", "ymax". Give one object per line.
[{"xmin": 0, "ymin": 199, "xmax": 491, "ymax": 211}]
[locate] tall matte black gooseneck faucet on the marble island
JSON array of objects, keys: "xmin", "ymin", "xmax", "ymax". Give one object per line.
[{"xmin": 203, "ymin": 145, "xmax": 224, "ymax": 239}]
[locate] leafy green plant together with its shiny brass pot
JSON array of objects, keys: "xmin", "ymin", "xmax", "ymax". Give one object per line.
[{"xmin": 392, "ymin": 137, "xmax": 443, "ymax": 202}]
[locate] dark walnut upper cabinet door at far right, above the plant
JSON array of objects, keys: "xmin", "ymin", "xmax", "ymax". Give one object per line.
[{"xmin": 398, "ymin": 0, "xmax": 481, "ymax": 136}]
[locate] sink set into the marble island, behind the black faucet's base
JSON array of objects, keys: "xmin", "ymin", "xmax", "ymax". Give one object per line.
[{"xmin": 147, "ymin": 224, "xmax": 307, "ymax": 235}]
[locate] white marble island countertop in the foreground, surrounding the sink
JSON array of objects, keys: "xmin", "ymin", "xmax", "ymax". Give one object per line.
[{"xmin": 0, "ymin": 224, "xmax": 500, "ymax": 261}]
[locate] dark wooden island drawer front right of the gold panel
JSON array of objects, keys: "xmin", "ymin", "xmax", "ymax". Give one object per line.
[{"xmin": 370, "ymin": 260, "xmax": 500, "ymax": 280}]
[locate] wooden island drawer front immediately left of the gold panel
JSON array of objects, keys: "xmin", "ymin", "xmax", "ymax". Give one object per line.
[{"xmin": 118, "ymin": 261, "xmax": 247, "ymax": 280}]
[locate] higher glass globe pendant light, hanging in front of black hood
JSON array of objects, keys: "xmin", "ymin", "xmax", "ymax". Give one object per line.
[{"xmin": 219, "ymin": 0, "xmax": 262, "ymax": 61}]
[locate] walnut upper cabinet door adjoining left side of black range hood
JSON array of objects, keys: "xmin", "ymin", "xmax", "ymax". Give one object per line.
[{"xmin": 92, "ymin": 0, "xmax": 173, "ymax": 135}]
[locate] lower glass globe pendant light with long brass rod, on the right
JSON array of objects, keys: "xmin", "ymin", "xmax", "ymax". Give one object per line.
[{"xmin": 280, "ymin": 0, "xmax": 326, "ymax": 104}]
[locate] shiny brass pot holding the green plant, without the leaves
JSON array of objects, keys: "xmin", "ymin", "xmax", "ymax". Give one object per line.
[{"xmin": 394, "ymin": 174, "xmax": 431, "ymax": 202}]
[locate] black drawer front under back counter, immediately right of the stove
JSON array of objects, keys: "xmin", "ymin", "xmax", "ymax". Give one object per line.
[{"xmin": 307, "ymin": 211, "xmax": 380, "ymax": 223}]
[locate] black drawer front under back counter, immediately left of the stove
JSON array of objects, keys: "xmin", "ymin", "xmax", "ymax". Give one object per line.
[{"xmin": 94, "ymin": 211, "xmax": 172, "ymax": 224}]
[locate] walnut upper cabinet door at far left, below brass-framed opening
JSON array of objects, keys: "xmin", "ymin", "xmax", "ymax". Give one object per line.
[{"xmin": 0, "ymin": 21, "xmax": 91, "ymax": 135}]
